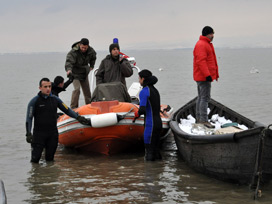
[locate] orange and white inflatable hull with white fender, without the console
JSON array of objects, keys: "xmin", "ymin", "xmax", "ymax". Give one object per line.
[{"xmin": 57, "ymin": 100, "xmax": 172, "ymax": 155}]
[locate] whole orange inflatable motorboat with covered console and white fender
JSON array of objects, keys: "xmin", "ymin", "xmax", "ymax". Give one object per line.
[{"xmin": 57, "ymin": 52, "xmax": 173, "ymax": 155}]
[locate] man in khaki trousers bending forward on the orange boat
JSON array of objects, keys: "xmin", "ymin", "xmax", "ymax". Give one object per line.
[{"xmin": 65, "ymin": 38, "xmax": 96, "ymax": 109}]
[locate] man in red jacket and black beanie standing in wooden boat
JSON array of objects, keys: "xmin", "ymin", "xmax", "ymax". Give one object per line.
[{"xmin": 194, "ymin": 26, "xmax": 219, "ymax": 128}]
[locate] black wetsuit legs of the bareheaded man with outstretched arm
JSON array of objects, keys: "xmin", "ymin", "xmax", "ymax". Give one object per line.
[{"xmin": 31, "ymin": 131, "xmax": 59, "ymax": 163}]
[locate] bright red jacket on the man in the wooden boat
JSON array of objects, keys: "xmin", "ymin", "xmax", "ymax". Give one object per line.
[{"xmin": 194, "ymin": 35, "xmax": 219, "ymax": 81}]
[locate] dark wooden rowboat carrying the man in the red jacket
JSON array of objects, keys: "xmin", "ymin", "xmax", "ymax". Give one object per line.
[{"xmin": 170, "ymin": 98, "xmax": 272, "ymax": 190}]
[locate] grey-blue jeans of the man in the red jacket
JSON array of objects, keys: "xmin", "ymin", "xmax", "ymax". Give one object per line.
[{"xmin": 196, "ymin": 81, "xmax": 211, "ymax": 122}]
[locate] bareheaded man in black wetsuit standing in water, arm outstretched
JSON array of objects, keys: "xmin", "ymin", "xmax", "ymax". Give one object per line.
[{"xmin": 26, "ymin": 78, "xmax": 89, "ymax": 163}]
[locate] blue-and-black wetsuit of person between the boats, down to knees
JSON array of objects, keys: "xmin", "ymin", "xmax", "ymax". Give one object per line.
[{"xmin": 138, "ymin": 76, "xmax": 162, "ymax": 144}]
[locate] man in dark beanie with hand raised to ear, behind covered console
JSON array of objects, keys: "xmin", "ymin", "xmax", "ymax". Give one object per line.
[{"xmin": 95, "ymin": 43, "xmax": 133, "ymax": 87}]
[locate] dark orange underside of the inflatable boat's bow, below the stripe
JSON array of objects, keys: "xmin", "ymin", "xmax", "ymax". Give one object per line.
[{"xmin": 59, "ymin": 122, "xmax": 146, "ymax": 155}]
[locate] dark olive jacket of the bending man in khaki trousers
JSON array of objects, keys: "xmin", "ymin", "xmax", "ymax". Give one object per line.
[{"xmin": 65, "ymin": 42, "xmax": 96, "ymax": 81}]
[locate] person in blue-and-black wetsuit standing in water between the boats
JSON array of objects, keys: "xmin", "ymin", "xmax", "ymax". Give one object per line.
[{"xmin": 134, "ymin": 69, "xmax": 162, "ymax": 161}]
